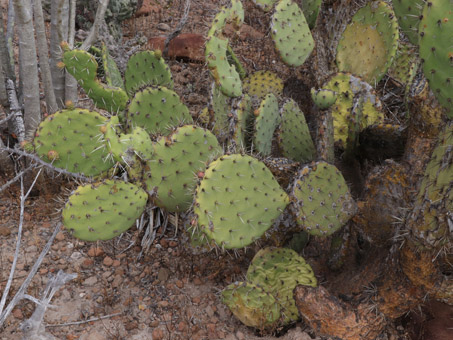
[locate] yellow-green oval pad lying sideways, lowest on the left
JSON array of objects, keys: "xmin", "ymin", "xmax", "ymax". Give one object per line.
[{"xmin": 62, "ymin": 180, "xmax": 148, "ymax": 241}]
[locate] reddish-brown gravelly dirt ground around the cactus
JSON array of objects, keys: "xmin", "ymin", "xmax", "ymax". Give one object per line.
[{"xmin": 0, "ymin": 0, "xmax": 332, "ymax": 340}]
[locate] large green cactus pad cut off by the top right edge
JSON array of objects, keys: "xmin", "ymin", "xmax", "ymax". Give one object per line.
[{"xmin": 419, "ymin": 0, "xmax": 453, "ymax": 119}]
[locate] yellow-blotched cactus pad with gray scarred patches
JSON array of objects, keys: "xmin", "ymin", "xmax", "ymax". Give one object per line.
[{"xmin": 323, "ymin": 73, "xmax": 384, "ymax": 149}]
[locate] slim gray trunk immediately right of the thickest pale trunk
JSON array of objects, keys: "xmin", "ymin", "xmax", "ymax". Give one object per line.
[{"xmin": 33, "ymin": 0, "xmax": 58, "ymax": 113}]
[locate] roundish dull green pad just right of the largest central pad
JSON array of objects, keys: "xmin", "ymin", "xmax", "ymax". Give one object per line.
[{"xmin": 292, "ymin": 162, "xmax": 356, "ymax": 236}]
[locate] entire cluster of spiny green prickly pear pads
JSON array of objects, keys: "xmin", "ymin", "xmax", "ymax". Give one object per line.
[{"xmin": 25, "ymin": 0, "xmax": 453, "ymax": 329}]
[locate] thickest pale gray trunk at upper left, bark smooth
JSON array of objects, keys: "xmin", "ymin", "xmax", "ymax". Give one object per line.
[{"xmin": 13, "ymin": 0, "xmax": 41, "ymax": 135}]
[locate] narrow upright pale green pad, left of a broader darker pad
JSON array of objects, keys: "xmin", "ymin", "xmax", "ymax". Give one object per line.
[{"xmin": 253, "ymin": 93, "xmax": 281, "ymax": 156}]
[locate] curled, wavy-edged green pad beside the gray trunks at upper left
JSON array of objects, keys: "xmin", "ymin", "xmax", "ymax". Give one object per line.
[{"xmin": 63, "ymin": 45, "xmax": 128, "ymax": 113}]
